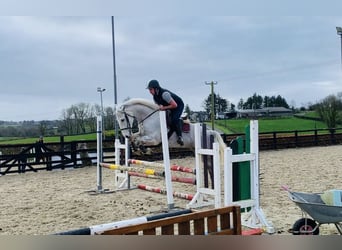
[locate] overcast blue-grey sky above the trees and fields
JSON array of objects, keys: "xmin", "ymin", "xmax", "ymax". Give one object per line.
[{"xmin": 0, "ymin": 16, "xmax": 342, "ymax": 121}]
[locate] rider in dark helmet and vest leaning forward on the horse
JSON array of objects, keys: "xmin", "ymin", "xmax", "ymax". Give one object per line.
[{"xmin": 147, "ymin": 80, "xmax": 184, "ymax": 146}]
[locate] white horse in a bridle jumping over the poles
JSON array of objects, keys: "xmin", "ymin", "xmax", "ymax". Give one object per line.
[{"xmin": 116, "ymin": 98, "xmax": 226, "ymax": 156}]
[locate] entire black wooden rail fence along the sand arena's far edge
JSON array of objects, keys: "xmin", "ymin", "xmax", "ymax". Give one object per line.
[{"xmin": 0, "ymin": 128, "xmax": 342, "ymax": 175}]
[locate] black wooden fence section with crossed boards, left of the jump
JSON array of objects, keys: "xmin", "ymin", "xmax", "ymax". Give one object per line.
[{"xmin": 0, "ymin": 140, "xmax": 114, "ymax": 175}]
